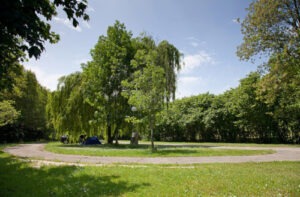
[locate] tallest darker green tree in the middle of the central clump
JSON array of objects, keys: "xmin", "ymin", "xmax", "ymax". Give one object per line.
[{"xmin": 83, "ymin": 21, "xmax": 134, "ymax": 143}]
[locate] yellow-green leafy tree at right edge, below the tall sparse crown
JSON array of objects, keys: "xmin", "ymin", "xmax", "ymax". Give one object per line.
[{"xmin": 257, "ymin": 50, "xmax": 300, "ymax": 142}]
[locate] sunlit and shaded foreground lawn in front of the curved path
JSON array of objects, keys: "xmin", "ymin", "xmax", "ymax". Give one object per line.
[{"xmin": 0, "ymin": 145, "xmax": 300, "ymax": 197}]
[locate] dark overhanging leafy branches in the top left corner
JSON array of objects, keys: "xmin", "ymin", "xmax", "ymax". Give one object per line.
[{"xmin": 0, "ymin": 0, "xmax": 89, "ymax": 88}]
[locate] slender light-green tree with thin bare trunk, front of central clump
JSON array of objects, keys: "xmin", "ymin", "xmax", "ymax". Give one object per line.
[{"xmin": 123, "ymin": 51, "xmax": 166, "ymax": 151}]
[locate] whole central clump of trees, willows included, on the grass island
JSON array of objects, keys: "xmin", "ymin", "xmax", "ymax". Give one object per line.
[{"xmin": 47, "ymin": 21, "xmax": 181, "ymax": 149}]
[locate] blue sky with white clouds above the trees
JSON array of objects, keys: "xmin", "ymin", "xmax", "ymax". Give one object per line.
[{"xmin": 24, "ymin": 0, "xmax": 257, "ymax": 98}]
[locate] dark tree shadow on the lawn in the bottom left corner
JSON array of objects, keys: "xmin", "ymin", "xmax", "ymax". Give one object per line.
[{"xmin": 0, "ymin": 151, "xmax": 150, "ymax": 197}]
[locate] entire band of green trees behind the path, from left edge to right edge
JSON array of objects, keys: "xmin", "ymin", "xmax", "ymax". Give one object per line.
[{"xmin": 0, "ymin": 0, "xmax": 300, "ymax": 143}]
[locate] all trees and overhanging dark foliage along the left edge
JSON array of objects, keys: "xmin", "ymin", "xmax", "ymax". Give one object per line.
[{"xmin": 0, "ymin": 0, "xmax": 89, "ymax": 142}]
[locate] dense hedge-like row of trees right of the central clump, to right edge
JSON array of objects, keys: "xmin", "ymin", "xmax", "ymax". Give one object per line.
[{"xmin": 156, "ymin": 0, "xmax": 300, "ymax": 143}]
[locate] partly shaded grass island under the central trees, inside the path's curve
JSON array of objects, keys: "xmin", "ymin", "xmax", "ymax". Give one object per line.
[{"xmin": 46, "ymin": 143, "xmax": 274, "ymax": 157}]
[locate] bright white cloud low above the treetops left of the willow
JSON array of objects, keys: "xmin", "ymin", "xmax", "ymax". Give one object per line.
[{"xmin": 25, "ymin": 65, "xmax": 63, "ymax": 91}]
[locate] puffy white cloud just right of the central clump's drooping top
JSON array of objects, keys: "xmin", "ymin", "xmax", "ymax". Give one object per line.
[{"xmin": 180, "ymin": 51, "xmax": 215, "ymax": 73}]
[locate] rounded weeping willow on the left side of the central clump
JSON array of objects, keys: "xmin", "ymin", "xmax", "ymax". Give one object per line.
[{"xmin": 47, "ymin": 72, "xmax": 102, "ymax": 142}]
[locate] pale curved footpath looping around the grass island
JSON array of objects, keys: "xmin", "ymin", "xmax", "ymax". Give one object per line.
[{"xmin": 4, "ymin": 144, "xmax": 300, "ymax": 164}]
